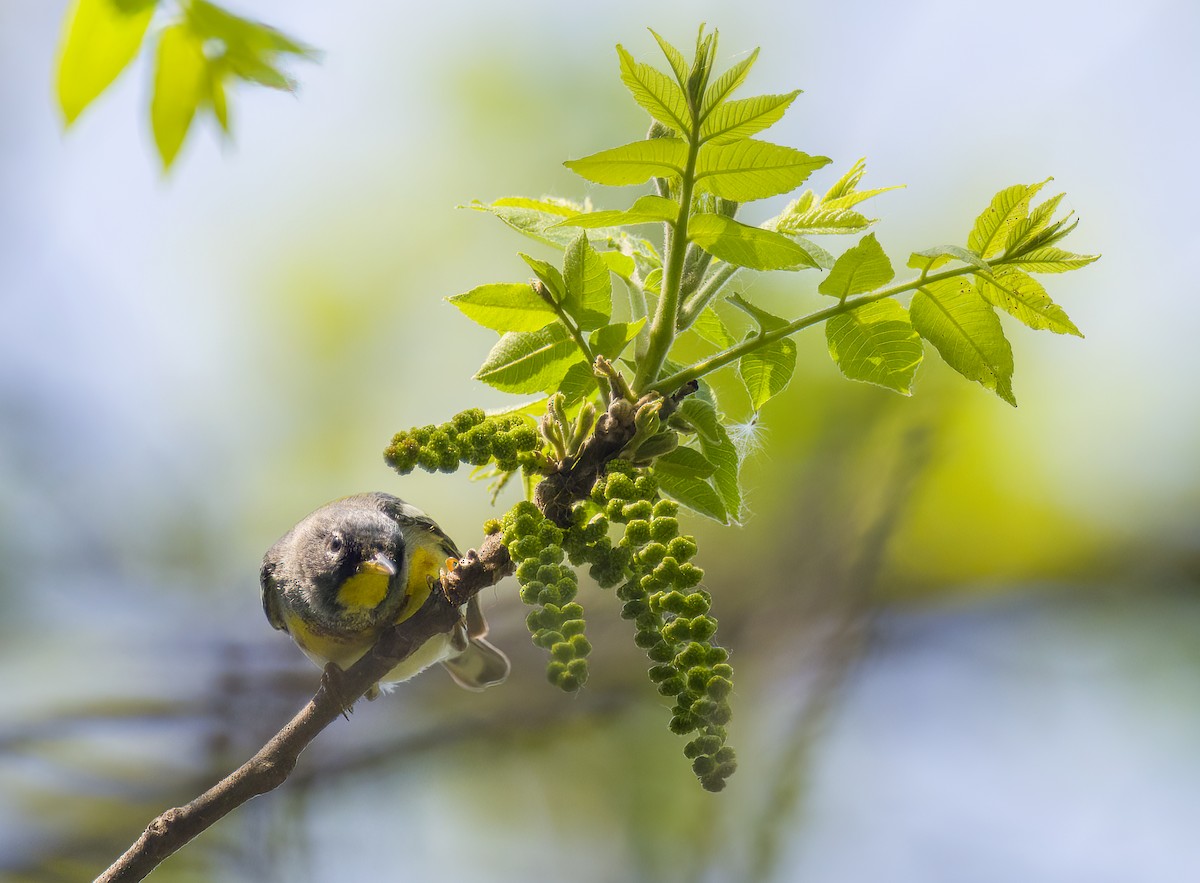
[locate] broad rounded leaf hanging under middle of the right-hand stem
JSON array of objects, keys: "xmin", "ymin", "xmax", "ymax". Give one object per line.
[{"xmin": 826, "ymin": 299, "xmax": 924, "ymax": 396}]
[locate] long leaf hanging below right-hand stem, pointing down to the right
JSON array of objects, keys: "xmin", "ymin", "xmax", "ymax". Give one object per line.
[{"xmin": 908, "ymin": 277, "xmax": 1016, "ymax": 408}]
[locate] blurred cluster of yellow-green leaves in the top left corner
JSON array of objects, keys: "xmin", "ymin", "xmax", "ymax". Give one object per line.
[{"xmin": 58, "ymin": 0, "xmax": 317, "ymax": 170}]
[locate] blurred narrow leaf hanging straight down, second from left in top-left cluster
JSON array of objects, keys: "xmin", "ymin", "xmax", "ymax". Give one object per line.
[{"xmin": 150, "ymin": 24, "xmax": 209, "ymax": 169}]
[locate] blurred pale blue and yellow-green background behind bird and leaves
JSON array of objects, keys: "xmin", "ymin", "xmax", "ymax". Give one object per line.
[{"xmin": 0, "ymin": 0, "xmax": 1200, "ymax": 883}]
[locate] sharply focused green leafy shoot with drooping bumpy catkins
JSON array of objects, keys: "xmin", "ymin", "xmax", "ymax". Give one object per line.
[{"xmin": 388, "ymin": 22, "xmax": 1096, "ymax": 791}]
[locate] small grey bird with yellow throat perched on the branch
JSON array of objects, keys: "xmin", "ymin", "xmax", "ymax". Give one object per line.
[{"xmin": 260, "ymin": 493, "xmax": 510, "ymax": 698}]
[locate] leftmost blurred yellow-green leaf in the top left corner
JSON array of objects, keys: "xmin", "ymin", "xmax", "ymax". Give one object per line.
[{"xmin": 58, "ymin": 0, "xmax": 155, "ymax": 126}]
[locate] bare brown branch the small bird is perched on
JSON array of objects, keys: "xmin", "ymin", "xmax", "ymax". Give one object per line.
[{"xmin": 96, "ymin": 534, "xmax": 512, "ymax": 883}]
